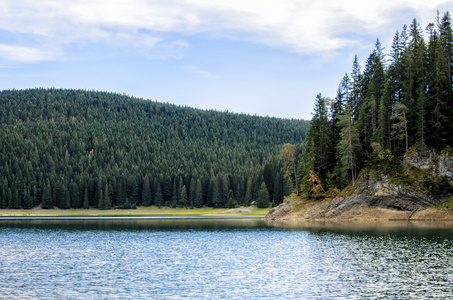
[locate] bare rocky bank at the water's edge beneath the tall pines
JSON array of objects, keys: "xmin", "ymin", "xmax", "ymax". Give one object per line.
[{"xmin": 265, "ymin": 151, "xmax": 453, "ymax": 221}]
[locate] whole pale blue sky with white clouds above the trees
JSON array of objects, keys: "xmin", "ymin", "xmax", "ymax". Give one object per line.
[{"xmin": 0, "ymin": 0, "xmax": 453, "ymax": 119}]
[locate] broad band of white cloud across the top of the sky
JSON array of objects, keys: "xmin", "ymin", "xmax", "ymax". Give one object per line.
[{"xmin": 0, "ymin": 0, "xmax": 452, "ymax": 62}]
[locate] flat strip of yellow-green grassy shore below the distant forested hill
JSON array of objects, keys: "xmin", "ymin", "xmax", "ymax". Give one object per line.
[{"xmin": 0, "ymin": 206, "xmax": 269, "ymax": 216}]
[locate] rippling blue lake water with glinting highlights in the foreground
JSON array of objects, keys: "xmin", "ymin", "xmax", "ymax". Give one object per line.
[{"xmin": 0, "ymin": 219, "xmax": 453, "ymax": 299}]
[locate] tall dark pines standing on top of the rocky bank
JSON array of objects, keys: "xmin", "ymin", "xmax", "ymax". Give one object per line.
[{"xmin": 299, "ymin": 12, "xmax": 453, "ymax": 194}]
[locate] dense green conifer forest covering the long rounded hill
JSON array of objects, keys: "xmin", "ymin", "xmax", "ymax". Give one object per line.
[{"xmin": 0, "ymin": 89, "xmax": 309, "ymax": 209}]
